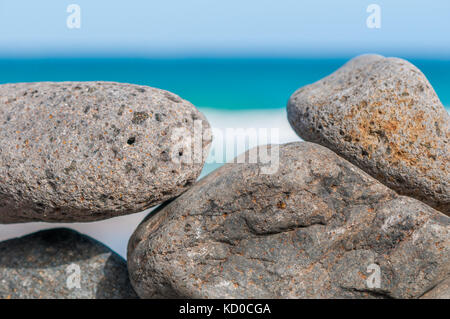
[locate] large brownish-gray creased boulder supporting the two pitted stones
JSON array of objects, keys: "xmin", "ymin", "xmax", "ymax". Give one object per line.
[{"xmin": 128, "ymin": 142, "xmax": 450, "ymax": 298}]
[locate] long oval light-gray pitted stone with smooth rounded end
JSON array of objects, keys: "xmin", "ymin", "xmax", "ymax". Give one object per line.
[{"xmin": 0, "ymin": 82, "xmax": 210, "ymax": 223}]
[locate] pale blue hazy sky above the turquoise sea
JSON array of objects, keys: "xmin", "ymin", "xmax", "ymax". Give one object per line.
[{"xmin": 0, "ymin": 0, "xmax": 450, "ymax": 59}]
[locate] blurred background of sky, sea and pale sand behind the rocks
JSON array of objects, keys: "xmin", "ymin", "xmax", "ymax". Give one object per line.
[{"xmin": 0, "ymin": 0, "xmax": 450, "ymax": 256}]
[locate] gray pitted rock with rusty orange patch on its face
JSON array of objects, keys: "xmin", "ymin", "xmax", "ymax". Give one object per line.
[{"xmin": 287, "ymin": 55, "xmax": 450, "ymax": 215}]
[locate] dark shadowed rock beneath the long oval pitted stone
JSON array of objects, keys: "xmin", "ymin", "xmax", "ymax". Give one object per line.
[{"xmin": 0, "ymin": 228, "xmax": 137, "ymax": 299}]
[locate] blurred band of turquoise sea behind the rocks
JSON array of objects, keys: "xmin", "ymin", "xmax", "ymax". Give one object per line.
[{"xmin": 0, "ymin": 58, "xmax": 450, "ymax": 110}]
